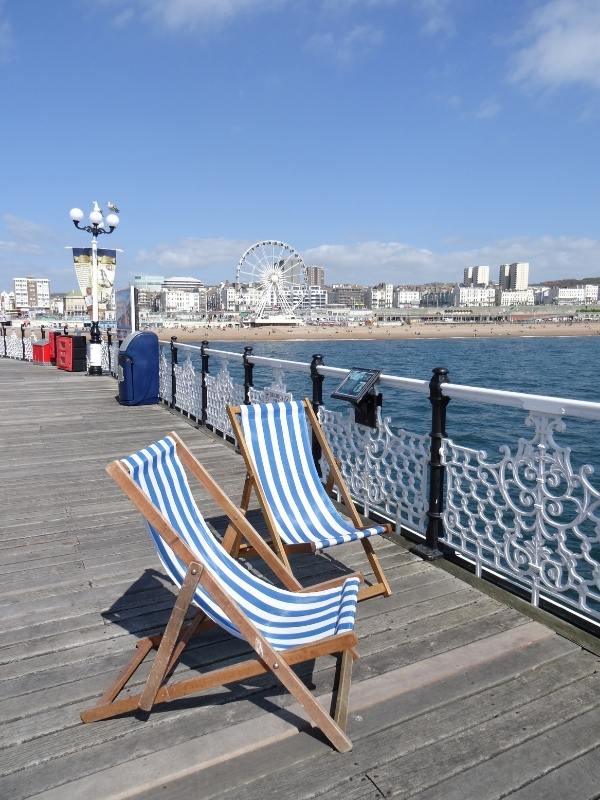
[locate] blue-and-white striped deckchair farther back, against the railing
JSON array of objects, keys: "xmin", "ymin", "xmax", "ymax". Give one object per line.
[{"xmin": 223, "ymin": 400, "xmax": 391, "ymax": 600}]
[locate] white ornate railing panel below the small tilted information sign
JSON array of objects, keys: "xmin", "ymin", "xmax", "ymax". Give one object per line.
[{"xmin": 319, "ymin": 407, "xmax": 429, "ymax": 533}]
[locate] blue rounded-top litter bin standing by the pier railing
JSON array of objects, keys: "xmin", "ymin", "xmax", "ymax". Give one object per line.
[{"xmin": 118, "ymin": 331, "xmax": 159, "ymax": 406}]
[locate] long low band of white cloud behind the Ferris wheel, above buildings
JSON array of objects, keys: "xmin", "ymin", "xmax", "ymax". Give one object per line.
[{"xmin": 136, "ymin": 231, "xmax": 600, "ymax": 284}]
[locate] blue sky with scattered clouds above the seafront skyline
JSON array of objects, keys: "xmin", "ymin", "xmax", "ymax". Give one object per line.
[{"xmin": 0, "ymin": 0, "xmax": 600, "ymax": 291}]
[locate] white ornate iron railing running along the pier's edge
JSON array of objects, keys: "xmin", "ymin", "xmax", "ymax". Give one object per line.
[{"xmin": 160, "ymin": 340, "xmax": 600, "ymax": 625}]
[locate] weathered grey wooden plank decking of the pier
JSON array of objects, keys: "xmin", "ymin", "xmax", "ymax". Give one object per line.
[{"xmin": 0, "ymin": 360, "xmax": 600, "ymax": 800}]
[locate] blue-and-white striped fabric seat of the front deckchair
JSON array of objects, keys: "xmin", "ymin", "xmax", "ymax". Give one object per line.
[{"xmin": 123, "ymin": 436, "xmax": 359, "ymax": 650}]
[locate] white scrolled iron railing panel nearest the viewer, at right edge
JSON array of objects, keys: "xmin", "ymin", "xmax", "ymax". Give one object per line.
[{"xmin": 442, "ymin": 412, "xmax": 600, "ymax": 619}]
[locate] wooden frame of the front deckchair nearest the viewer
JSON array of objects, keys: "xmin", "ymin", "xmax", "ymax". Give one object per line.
[{"xmin": 81, "ymin": 433, "xmax": 362, "ymax": 752}]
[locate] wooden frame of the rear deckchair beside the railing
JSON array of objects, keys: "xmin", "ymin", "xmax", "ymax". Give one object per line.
[{"xmin": 223, "ymin": 398, "xmax": 392, "ymax": 600}]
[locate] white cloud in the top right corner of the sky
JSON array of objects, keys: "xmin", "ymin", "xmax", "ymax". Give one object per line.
[{"xmin": 512, "ymin": 0, "xmax": 600, "ymax": 88}]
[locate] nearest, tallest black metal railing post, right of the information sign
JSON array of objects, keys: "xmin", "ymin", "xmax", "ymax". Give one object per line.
[{"xmin": 413, "ymin": 367, "xmax": 450, "ymax": 561}]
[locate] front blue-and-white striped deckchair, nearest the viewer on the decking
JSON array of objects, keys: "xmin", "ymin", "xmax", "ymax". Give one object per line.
[{"xmin": 81, "ymin": 433, "xmax": 360, "ymax": 752}]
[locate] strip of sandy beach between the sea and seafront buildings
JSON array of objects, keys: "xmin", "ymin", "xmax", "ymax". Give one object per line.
[{"xmin": 151, "ymin": 321, "xmax": 600, "ymax": 342}]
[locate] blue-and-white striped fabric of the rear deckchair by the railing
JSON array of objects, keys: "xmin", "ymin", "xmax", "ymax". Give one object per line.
[{"xmin": 240, "ymin": 401, "xmax": 385, "ymax": 550}]
